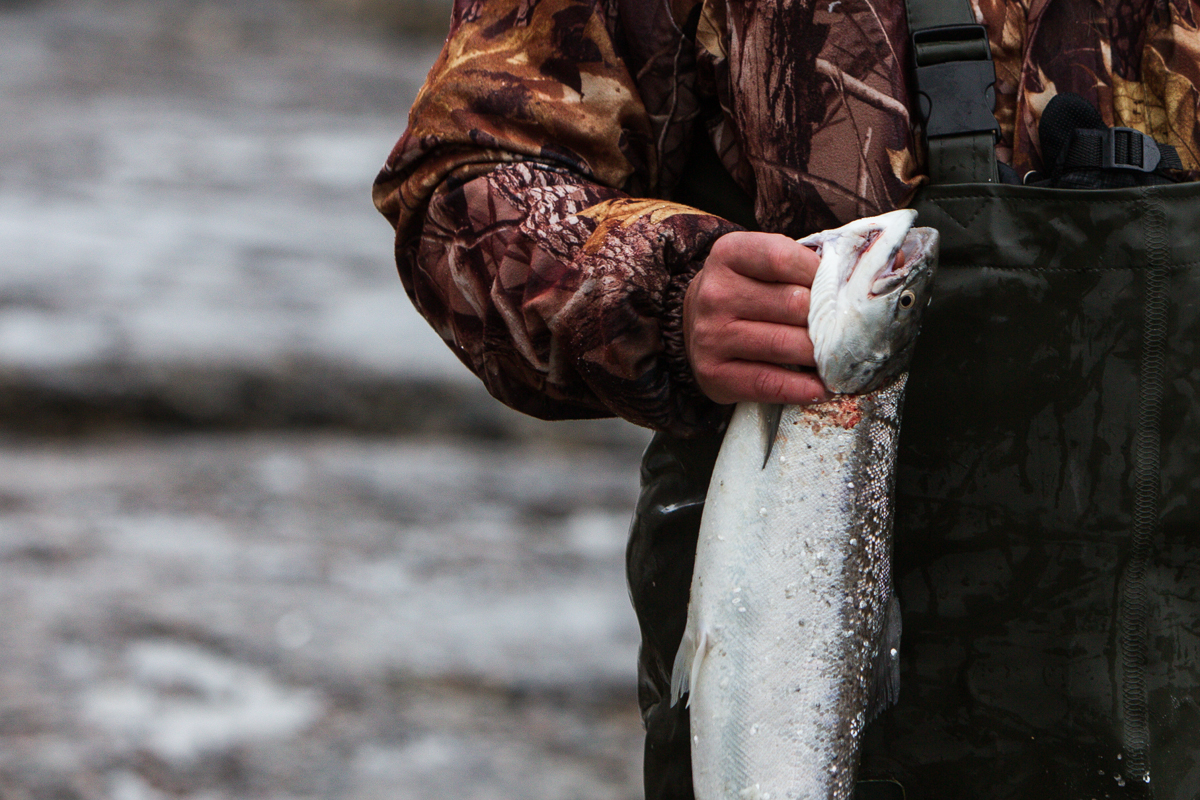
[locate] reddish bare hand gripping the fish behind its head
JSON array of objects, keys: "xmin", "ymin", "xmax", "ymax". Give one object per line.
[{"xmin": 683, "ymin": 231, "xmax": 829, "ymax": 404}]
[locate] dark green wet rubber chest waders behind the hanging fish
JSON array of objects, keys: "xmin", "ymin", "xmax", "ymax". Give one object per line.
[{"xmin": 628, "ymin": 0, "xmax": 1200, "ymax": 800}]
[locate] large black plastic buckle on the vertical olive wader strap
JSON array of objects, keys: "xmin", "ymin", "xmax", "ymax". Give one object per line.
[{"xmin": 912, "ymin": 25, "xmax": 1000, "ymax": 139}]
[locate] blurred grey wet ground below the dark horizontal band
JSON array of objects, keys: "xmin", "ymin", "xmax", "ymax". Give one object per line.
[{"xmin": 0, "ymin": 433, "xmax": 640, "ymax": 800}]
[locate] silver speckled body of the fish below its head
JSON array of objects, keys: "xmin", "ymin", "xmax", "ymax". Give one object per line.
[{"xmin": 679, "ymin": 388, "xmax": 904, "ymax": 800}]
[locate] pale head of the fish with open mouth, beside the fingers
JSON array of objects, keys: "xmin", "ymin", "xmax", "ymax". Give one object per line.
[{"xmin": 799, "ymin": 209, "xmax": 938, "ymax": 395}]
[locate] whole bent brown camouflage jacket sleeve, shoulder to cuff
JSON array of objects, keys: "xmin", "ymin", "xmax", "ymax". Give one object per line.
[{"xmin": 374, "ymin": 0, "xmax": 736, "ymax": 435}]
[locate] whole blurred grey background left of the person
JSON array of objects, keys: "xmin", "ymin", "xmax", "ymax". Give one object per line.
[{"xmin": 0, "ymin": 0, "xmax": 646, "ymax": 800}]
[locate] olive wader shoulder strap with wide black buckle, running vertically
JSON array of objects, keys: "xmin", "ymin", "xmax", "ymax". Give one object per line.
[{"xmin": 905, "ymin": 0, "xmax": 1000, "ymax": 185}]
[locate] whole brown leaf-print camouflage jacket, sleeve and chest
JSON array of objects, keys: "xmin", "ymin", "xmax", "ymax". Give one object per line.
[{"xmin": 374, "ymin": 0, "xmax": 1200, "ymax": 435}]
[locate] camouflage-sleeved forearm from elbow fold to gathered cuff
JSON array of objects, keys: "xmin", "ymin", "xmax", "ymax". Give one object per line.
[{"xmin": 397, "ymin": 164, "xmax": 736, "ymax": 435}]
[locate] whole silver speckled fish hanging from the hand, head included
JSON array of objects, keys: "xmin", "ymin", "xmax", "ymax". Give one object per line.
[{"xmin": 671, "ymin": 209, "xmax": 938, "ymax": 800}]
